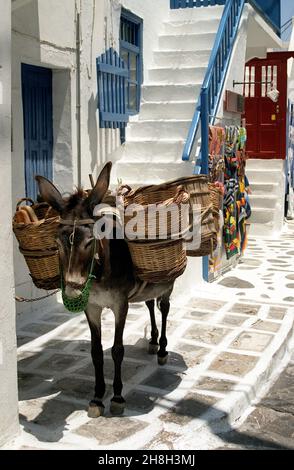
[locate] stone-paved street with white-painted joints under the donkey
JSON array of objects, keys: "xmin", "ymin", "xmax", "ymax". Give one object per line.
[{"xmin": 9, "ymin": 226, "xmax": 294, "ymax": 449}]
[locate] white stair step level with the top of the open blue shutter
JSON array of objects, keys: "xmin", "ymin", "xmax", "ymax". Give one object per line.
[{"xmin": 153, "ymin": 49, "xmax": 211, "ymax": 67}]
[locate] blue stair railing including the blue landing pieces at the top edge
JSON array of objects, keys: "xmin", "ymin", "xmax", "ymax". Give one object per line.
[{"xmin": 170, "ymin": 0, "xmax": 281, "ymax": 173}]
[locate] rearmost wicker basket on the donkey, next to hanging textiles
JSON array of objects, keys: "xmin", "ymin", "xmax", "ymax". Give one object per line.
[{"xmin": 163, "ymin": 175, "xmax": 217, "ymax": 256}]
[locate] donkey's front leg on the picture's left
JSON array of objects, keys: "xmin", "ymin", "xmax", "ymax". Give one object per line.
[{"xmin": 85, "ymin": 305, "xmax": 105, "ymax": 418}]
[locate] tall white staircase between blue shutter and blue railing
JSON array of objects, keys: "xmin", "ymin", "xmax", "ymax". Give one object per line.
[{"xmin": 112, "ymin": 6, "xmax": 223, "ymax": 186}]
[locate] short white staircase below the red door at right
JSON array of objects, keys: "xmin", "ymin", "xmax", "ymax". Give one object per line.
[{"xmin": 246, "ymin": 159, "xmax": 285, "ymax": 237}]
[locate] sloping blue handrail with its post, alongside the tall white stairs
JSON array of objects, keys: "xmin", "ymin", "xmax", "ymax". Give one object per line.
[{"xmin": 182, "ymin": 0, "xmax": 246, "ymax": 174}]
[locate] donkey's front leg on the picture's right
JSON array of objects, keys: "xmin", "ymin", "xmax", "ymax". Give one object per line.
[{"xmin": 110, "ymin": 301, "xmax": 129, "ymax": 415}]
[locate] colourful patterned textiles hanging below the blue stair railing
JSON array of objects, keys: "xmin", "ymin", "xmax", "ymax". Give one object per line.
[{"xmin": 208, "ymin": 125, "xmax": 251, "ymax": 277}]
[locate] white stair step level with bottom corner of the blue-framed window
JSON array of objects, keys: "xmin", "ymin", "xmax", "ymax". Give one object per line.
[{"xmin": 139, "ymin": 101, "xmax": 196, "ymax": 121}]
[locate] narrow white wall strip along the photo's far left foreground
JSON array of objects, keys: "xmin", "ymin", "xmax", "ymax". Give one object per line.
[{"xmin": 0, "ymin": 0, "xmax": 18, "ymax": 446}]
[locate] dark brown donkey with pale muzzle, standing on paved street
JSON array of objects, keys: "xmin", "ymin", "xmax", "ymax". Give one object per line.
[{"xmin": 36, "ymin": 162, "xmax": 174, "ymax": 418}]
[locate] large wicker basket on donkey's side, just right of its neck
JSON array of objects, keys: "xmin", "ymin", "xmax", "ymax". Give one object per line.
[{"xmin": 124, "ymin": 184, "xmax": 189, "ymax": 283}]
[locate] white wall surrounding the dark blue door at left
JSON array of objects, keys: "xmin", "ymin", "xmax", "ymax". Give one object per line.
[{"xmin": 12, "ymin": 0, "xmax": 77, "ymax": 313}]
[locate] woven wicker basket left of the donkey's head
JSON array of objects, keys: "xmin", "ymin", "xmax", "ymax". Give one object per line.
[{"xmin": 12, "ymin": 198, "xmax": 60, "ymax": 290}]
